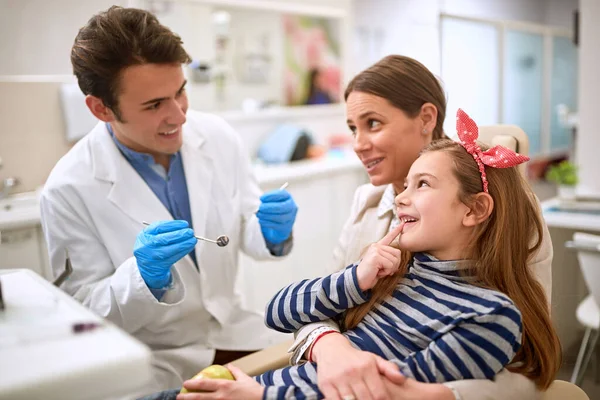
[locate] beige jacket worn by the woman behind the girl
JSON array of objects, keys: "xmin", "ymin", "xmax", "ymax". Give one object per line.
[{"xmin": 296, "ymin": 184, "xmax": 552, "ymax": 400}]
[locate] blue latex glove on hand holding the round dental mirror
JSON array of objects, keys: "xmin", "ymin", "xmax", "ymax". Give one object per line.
[{"xmin": 133, "ymin": 221, "xmax": 198, "ymax": 289}]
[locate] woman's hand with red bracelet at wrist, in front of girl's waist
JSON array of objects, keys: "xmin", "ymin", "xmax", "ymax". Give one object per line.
[{"xmin": 312, "ymin": 333, "xmax": 406, "ymax": 400}]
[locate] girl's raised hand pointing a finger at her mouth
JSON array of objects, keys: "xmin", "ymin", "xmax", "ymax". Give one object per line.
[{"xmin": 356, "ymin": 223, "xmax": 404, "ymax": 291}]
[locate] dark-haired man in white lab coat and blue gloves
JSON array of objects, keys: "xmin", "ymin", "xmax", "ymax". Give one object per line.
[{"xmin": 41, "ymin": 7, "xmax": 297, "ymax": 393}]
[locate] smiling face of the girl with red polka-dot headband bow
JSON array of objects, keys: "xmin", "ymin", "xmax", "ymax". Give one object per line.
[{"xmin": 395, "ymin": 151, "xmax": 473, "ymax": 260}]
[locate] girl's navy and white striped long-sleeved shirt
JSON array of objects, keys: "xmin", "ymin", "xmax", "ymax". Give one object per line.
[{"xmin": 256, "ymin": 254, "xmax": 522, "ymax": 399}]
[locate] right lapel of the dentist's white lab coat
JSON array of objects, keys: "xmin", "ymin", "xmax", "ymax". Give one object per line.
[{"xmin": 181, "ymin": 126, "xmax": 215, "ymax": 236}]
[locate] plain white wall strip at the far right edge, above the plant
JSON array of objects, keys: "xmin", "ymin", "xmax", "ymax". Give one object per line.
[{"xmin": 576, "ymin": 0, "xmax": 600, "ymax": 197}]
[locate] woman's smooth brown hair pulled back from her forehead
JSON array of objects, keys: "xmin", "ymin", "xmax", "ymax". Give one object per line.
[{"xmin": 344, "ymin": 55, "xmax": 446, "ymax": 141}]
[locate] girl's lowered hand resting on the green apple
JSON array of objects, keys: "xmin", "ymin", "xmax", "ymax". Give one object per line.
[{"xmin": 177, "ymin": 364, "xmax": 264, "ymax": 400}]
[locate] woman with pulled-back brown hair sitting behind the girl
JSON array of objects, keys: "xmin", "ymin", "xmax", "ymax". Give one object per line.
[{"xmin": 282, "ymin": 55, "xmax": 552, "ymax": 400}]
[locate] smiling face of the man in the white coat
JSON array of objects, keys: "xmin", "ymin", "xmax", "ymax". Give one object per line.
[{"xmin": 105, "ymin": 64, "xmax": 188, "ymax": 165}]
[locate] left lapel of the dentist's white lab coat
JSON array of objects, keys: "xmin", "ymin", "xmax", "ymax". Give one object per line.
[{"xmin": 91, "ymin": 123, "xmax": 173, "ymax": 225}]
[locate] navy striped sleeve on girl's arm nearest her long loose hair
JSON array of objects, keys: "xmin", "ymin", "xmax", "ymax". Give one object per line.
[{"xmin": 392, "ymin": 305, "xmax": 522, "ymax": 383}]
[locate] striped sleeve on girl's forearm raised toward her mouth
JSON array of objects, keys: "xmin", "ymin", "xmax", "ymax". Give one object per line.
[{"xmin": 265, "ymin": 265, "xmax": 370, "ymax": 333}]
